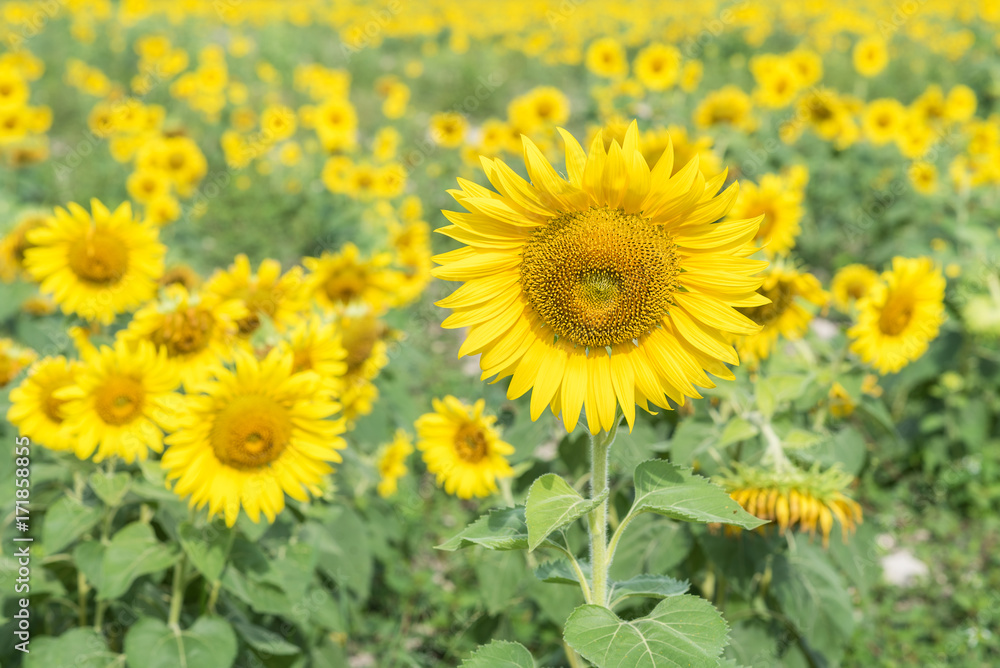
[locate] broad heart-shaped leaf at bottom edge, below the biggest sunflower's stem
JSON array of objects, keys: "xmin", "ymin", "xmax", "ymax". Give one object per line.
[{"xmin": 565, "ymin": 595, "xmax": 728, "ymax": 668}]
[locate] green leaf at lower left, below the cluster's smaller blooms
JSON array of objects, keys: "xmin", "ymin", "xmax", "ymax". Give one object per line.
[{"xmin": 98, "ymin": 522, "xmax": 179, "ymax": 601}]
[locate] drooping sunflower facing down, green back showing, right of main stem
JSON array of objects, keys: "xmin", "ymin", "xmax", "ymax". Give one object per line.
[{"xmin": 718, "ymin": 465, "xmax": 862, "ymax": 547}]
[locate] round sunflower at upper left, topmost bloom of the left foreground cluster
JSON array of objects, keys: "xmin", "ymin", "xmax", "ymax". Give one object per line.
[{"xmin": 24, "ymin": 199, "xmax": 166, "ymax": 325}]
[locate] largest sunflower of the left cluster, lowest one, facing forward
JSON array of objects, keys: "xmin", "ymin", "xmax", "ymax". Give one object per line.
[{"xmin": 162, "ymin": 348, "xmax": 345, "ymax": 526}]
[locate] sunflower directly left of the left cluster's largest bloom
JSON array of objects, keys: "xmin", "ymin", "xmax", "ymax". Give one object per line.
[{"xmin": 52, "ymin": 339, "xmax": 180, "ymax": 464}]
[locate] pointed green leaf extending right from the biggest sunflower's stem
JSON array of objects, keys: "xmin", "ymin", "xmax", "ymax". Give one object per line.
[{"xmin": 629, "ymin": 459, "xmax": 765, "ymax": 529}]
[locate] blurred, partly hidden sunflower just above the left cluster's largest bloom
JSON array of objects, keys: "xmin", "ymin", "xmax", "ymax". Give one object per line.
[{"xmin": 205, "ymin": 253, "xmax": 308, "ymax": 336}]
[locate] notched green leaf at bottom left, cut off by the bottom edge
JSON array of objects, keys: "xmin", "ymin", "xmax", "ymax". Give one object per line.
[{"xmin": 125, "ymin": 617, "xmax": 237, "ymax": 668}]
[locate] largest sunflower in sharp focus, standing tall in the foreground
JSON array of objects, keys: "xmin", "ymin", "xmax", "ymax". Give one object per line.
[{"xmin": 434, "ymin": 122, "xmax": 767, "ymax": 433}]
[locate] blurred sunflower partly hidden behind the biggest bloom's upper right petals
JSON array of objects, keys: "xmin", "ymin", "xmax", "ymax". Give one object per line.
[{"xmin": 729, "ymin": 174, "xmax": 803, "ymax": 255}]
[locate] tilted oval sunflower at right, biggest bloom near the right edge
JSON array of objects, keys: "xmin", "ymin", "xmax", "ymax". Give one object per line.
[{"xmin": 847, "ymin": 257, "xmax": 945, "ymax": 375}]
